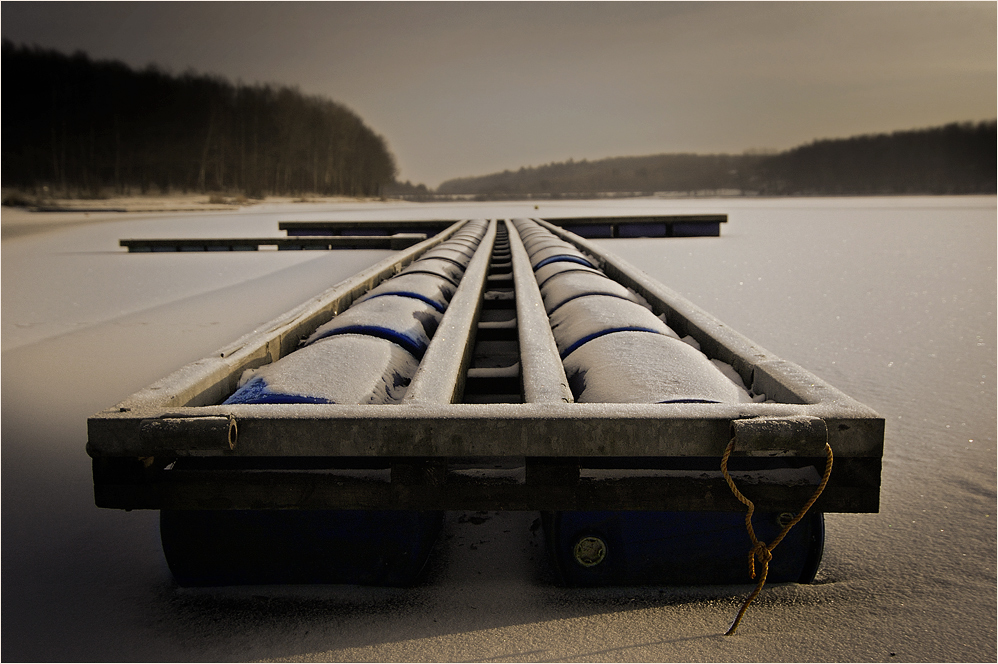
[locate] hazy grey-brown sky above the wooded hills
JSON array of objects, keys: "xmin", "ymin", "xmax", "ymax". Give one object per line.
[{"xmin": 0, "ymin": 0, "xmax": 998, "ymax": 187}]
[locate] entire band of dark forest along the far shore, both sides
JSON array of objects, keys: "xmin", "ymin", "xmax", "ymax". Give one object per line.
[{"xmin": 0, "ymin": 40, "xmax": 996, "ymax": 199}]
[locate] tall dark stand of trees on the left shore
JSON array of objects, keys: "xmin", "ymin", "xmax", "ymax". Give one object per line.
[{"xmin": 2, "ymin": 40, "xmax": 396, "ymax": 197}]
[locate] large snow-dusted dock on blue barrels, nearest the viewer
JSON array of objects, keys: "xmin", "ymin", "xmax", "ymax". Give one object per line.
[{"xmin": 87, "ymin": 219, "xmax": 884, "ymax": 585}]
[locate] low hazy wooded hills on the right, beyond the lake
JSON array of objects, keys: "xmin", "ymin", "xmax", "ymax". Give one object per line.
[{"xmin": 437, "ymin": 121, "xmax": 996, "ymax": 198}]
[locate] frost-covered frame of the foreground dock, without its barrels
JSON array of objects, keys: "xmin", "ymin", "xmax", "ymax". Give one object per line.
[{"xmin": 87, "ymin": 220, "xmax": 884, "ymax": 512}]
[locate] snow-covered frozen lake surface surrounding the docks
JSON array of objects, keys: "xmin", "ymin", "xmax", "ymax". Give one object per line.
[{"xmin": 0, "ymin": 196, "xmax": 998, "ymax": 661}]
